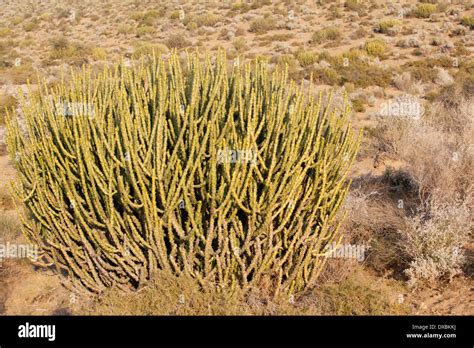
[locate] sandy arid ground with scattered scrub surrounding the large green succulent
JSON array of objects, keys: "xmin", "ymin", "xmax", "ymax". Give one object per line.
[{"xmin": 0, "ymin": 0, "xmax": 474, "ymax": 315}]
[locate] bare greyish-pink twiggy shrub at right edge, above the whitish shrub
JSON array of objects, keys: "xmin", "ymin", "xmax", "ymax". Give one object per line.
[{"xmin": 379, "ymin": 95, "xmax": 474, "ymax": 202}]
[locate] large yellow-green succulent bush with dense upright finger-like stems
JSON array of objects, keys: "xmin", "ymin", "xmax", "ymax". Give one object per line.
[{"xmin": 7, "ymin": 53, "xmax": 359, "ymax": 293}]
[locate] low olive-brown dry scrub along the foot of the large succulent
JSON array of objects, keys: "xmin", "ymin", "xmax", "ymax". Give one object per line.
[{"xmin": 80, "ymin": 266, "xmax": 408, "ymax": 315}]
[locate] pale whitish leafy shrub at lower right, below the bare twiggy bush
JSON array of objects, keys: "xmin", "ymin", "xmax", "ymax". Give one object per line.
[{"xmin": 400, "ymin": 202, "xmax": 473, "ymax": 286}]
